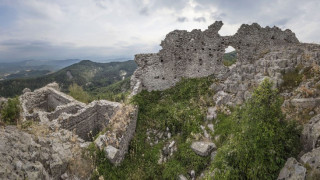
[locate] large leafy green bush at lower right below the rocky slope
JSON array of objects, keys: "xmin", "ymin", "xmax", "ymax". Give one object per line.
[{"xmin": 212, "ymin": 79, "xmax": 300, "ymax": 179}]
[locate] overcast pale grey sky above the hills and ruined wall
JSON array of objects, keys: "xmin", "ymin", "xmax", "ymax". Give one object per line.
[{"xmin": 0, "ymin": 0, "xmax": 320, "ymax": 62}]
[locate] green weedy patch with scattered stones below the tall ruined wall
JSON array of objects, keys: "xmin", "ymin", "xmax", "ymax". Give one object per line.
[{"xmin": 90, "ymin": 77, "xmax": 214, "ymax": 179}]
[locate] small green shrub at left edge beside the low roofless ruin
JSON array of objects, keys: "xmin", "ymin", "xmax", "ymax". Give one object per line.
[{"xmin": 1, "ymin": 97, "xmax": 20, "ymax": 124}]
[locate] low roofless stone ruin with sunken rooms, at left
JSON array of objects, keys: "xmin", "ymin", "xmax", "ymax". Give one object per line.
[{"xmin": 20, "ymin": 83, "xmax": 138, "ymax": 164}]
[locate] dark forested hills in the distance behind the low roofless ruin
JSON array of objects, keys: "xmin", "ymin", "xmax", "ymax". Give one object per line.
[{"xmin": 0, "ymin": 60, "xmax": 137, "ymax": 97}]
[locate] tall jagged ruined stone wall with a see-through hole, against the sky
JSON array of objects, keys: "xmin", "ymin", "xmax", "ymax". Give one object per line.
[{"xmin": 131, "ymin": 21, "xmax": 299, "ymax": 91}]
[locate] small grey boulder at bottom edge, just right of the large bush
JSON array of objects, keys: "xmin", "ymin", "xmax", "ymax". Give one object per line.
[{"xmin": 278, "ymin": 158, "xmax": 307, "ymax": 180}]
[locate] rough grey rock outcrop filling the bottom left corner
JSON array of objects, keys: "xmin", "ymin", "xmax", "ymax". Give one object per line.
[{"xmin": 0, "ymin": 126, "xmax": 92, "ymax": 179}]
